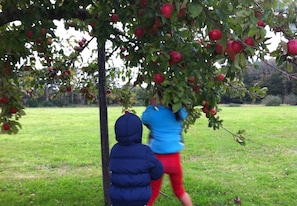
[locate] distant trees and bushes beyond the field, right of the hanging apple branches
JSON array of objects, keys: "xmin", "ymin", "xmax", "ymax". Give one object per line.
[{"xmin": 221, "ymin": 59, "xmax": 297, "ymax": 105}]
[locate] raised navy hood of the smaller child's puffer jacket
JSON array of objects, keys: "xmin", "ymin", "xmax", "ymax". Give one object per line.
[{"xmin": 114, "ymin": 113, "xmax": 142, "ymax": 145}]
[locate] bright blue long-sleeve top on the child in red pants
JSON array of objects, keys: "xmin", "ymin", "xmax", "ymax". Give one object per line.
[{"xmin": 141, "ymin": 105, "xmax": 188, "ymax": 154}]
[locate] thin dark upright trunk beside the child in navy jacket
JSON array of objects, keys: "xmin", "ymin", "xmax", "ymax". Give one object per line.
[{"xmin": 98, "ymin": 42, "xmax": 110, "ymax": 205}]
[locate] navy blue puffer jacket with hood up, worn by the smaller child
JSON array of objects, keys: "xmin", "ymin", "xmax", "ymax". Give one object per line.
[{"xmin": 109, "ymin": 113, "xmax": 164, "ymax": 206}]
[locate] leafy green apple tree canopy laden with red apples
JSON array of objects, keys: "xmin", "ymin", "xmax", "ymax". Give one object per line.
[{"xmin": 0, "ymin": 0, "xmax": 297, "ymax": 204}]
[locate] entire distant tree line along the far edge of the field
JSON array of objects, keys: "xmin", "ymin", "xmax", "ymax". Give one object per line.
[{"xmin": 23, "ymin": 59, "xmax": 297, "ymax": 107}]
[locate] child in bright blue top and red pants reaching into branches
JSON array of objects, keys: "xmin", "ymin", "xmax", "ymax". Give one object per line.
[{"xmin": 142, "ymin": 93, "xmax": 192, "ymax": 206}]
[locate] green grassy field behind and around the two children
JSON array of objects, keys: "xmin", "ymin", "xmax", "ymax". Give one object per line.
[{"xmin": 0, "ymin": 106, "xmax": 297, "ymax": 206}]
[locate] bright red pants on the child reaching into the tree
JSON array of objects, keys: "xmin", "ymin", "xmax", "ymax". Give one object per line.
[{"xmin": 147, "ymin": 153, "xmax": 185, "ymax": 206}]
